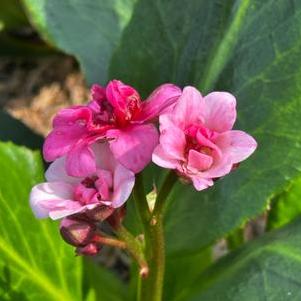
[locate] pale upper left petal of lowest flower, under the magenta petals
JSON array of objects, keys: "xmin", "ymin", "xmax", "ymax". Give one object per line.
[{"xmin": 45, "ymin": 156, "xmax": 80, "ymax": 184}]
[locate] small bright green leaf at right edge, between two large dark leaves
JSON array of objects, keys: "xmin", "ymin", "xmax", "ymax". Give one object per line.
[{"xmin": 267, "ymin": 178, "xmax": 301, "ymax": 230}]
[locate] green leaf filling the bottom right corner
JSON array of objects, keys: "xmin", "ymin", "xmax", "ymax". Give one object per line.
[{"xmin": 185, "ymin": 219, "xmax": 301, "ymax": 301}]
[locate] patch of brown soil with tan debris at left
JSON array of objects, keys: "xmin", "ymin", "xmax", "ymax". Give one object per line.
[{"xmin": 0, "ymin": 55, "xmax": 89, "ymax": 136}]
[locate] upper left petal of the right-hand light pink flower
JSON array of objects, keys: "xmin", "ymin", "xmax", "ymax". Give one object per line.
[{"xmin": 172, "ymin": 86, "xmax": 205, "ymax": 129}]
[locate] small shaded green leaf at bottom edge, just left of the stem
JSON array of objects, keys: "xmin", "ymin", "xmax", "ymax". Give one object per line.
[{"xmin": 84, "ymin": 259, "xmax": 127, "ymax": 301}]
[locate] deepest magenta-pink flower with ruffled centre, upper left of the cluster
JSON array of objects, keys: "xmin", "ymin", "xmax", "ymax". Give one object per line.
[{"xmin": 43, "ymin": 80, "xmax": 181, "ymax": 176}]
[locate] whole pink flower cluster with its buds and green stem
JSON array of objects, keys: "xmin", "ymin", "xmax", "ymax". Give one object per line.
[{"xmin": 30, "ymin": 80, "xmax": 257, "ymax": 301}]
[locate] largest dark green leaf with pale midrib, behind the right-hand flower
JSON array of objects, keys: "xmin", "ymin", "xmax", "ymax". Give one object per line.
[{"xmin": 110, "ymin": 0, "xmax": 301, "ymax": 252}]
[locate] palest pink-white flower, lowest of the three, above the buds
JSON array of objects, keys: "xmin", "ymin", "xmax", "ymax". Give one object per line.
[{"xmin": 30, "ymin": 143, "xmax": 135, "ymax": 219}]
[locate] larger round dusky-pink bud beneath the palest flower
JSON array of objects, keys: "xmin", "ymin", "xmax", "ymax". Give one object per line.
[{"xmin": 60, "ymin": 218, "xmax": 96, "ymax": 247}]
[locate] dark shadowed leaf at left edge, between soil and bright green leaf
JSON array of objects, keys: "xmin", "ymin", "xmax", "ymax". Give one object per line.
[{"xmin": 0, "ymin": 111, "xmax": 43, "ymax": 149}]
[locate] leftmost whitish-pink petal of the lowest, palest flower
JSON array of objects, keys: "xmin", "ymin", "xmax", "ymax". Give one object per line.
[{"xmin": 30, "ymin": 182, "xmax": 73, "ymax": 218}]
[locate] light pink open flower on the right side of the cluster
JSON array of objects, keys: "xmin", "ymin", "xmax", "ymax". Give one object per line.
[{"xmin": 153, "ymin": 87, "xmax": 257, "ymax": 190}]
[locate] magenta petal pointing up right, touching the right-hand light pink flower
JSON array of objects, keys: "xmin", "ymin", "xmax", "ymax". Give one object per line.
[{"xmin": 136, "ymin": 84, "xmax": 182, "ymax": 123}]
